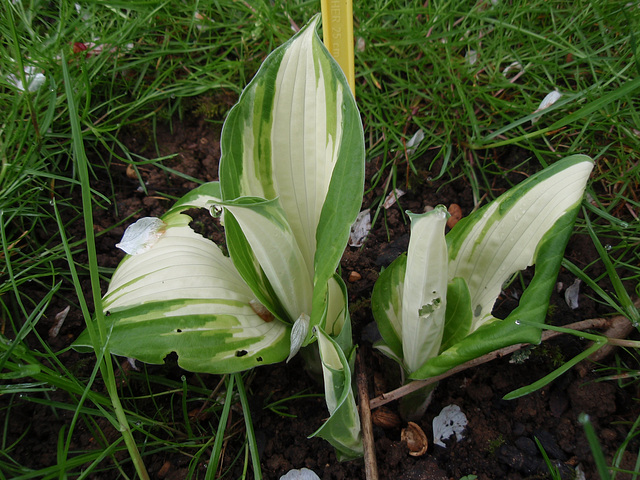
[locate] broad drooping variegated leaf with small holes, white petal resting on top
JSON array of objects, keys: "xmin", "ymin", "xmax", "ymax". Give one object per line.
[{"xmin": 74, "ymin": 204, "xmax": 289, "ymax": 373}]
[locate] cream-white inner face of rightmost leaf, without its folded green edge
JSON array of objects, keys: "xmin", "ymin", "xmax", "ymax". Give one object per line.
[{"xmin": 447, "ymin": 155, "xmax": 593, "ymax": 331}]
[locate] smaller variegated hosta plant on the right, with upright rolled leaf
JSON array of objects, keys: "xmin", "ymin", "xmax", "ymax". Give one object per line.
[{"xmin": 371, "ymin": 155, "xmax": 593, "ymax": 415}]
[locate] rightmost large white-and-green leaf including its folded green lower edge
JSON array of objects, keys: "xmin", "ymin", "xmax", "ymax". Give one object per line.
[{"xmin": 411, "ymin": 155, "xmax": 593, "ymax": 379}]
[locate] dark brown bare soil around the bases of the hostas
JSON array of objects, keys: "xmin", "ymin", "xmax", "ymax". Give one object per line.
[{"xmin": 6, "ymin": 109, "xmax": 640, "ymax": 480}]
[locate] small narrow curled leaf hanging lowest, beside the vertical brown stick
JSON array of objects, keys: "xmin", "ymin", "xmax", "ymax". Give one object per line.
[{"xmin": 311, "ymin": 327, "xmax": 363, "ymax": 461}]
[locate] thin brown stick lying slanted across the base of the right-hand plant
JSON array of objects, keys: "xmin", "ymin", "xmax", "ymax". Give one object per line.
[{"xmin": 369, "ymin": 315, "xmax": 629, "ymax": 410}]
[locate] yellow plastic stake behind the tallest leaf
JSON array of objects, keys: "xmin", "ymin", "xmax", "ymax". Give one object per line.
[{"xmin": 321, "ymin": 0, "xmax": 356, "ymax": 96}]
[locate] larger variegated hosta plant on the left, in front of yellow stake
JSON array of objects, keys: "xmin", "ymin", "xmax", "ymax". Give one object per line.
[{"xmin": 76, "ymin": 13, "xmax": 364, "ymax": 458}]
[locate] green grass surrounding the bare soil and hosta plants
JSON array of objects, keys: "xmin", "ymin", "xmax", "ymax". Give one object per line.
[{"xmin": 0, "ymin": 0, "xmax": 640, "ymax": 478}]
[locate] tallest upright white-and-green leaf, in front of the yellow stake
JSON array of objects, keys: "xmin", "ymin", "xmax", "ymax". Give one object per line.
[{"xmin": 220, "ymin": 17, "xmax": 364, "ymax": 335}]
